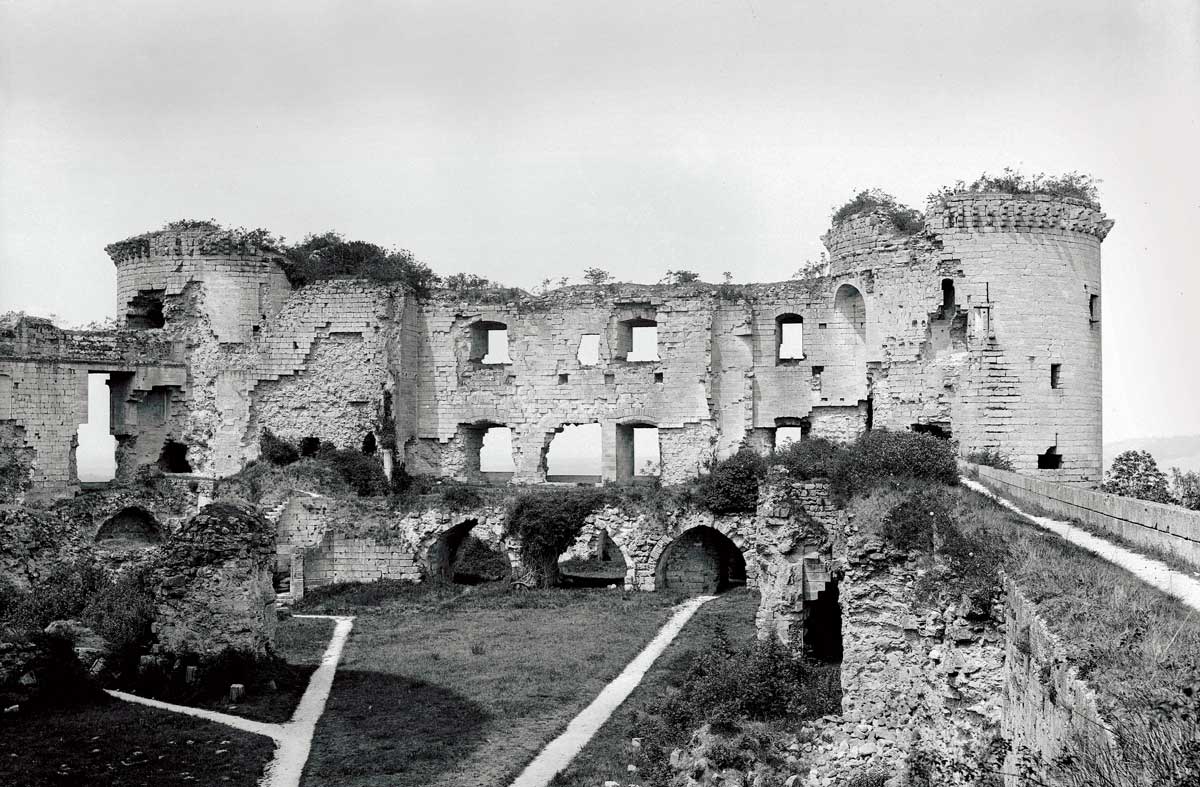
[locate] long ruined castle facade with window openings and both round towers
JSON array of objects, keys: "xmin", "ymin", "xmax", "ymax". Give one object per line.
[{"xmin": 0, "ymin": 193, "xmax": 1111, "ymax": 497}]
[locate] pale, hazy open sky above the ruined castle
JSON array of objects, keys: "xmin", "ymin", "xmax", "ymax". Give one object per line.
[{"xmin": 0, "ymin": 0, "xmax": 1200, "ymax": 440}]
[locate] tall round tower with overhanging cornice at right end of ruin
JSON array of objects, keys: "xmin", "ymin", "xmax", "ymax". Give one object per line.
[{"xmin": 926, "ymin": 193, "xmax": 1112, "ymax": 483}]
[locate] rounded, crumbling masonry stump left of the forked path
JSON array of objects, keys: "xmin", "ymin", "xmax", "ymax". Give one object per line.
[{"xmin": 154, "ymin": 503, "xmax": 275, "ymax": 655}]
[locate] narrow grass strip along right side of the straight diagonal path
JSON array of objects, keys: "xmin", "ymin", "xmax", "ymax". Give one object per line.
[{"xmin": 552, "ymin": 588, "xmax": 758, "ymax": 787}]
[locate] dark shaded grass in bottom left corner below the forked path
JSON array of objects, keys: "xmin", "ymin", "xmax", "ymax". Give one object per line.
[{"xmin": 0, "ymin": 699, "xmax": 275, "ymax": 787}]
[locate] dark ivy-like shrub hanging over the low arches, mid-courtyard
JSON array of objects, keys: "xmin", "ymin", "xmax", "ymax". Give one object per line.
[{"xmin": 504, "ymin": 488, "xmax": 605, "ymax": 587}]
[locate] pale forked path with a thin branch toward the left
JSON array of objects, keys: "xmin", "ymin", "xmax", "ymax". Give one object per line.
[{"xmin": 108, "ymin": 614, "xmax": 354, "ymax": 787}]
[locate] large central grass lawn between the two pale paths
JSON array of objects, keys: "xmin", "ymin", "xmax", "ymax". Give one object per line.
[{"xmin": 297, "ymin": 583, "xmax": 696, "ymax": 787}]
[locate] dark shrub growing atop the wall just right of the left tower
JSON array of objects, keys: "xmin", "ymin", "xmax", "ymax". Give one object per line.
[{"xmin": 284, "ymin": 232, "xmax": 440, "ymax": 298}]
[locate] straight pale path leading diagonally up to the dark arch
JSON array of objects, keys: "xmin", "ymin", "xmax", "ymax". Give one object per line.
[{"xmin": 512, "ymin": 596, "xmax": 716, "ymax": 787}]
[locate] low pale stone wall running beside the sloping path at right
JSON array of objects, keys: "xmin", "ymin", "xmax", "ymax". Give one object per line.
[{"xmin": 961, "ymin": 462, "xmax": 1200, "ymax": 567}]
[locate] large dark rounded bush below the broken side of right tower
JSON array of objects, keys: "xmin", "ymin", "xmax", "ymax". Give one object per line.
[{"xmin": 833, "ymin": 429, "xmax": 959, "ymax": 500}]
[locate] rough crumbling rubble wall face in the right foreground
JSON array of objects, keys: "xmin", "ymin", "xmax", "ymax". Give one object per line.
[{"xmin": 805, "ymin": 524, "xmax": 1004, "ymax": 785}]
